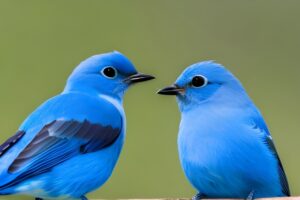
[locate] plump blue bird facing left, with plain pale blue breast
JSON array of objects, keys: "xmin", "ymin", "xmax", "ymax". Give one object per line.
[{"xmin": 158, "ymin": 61, "xmax": 290, "ymax": 199}]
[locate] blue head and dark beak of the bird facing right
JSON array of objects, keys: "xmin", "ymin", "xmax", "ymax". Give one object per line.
[{"xmin": 64, "ymin": 51, "xmax": 154, "ymax": 99}]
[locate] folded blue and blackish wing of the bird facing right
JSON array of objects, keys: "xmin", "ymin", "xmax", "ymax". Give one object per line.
[{"xmin": 0, "ymin": 120, "xmax": 121, "ymax": 189}]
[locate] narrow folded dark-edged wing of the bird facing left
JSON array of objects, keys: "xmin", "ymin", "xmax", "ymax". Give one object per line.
[{"xmin": 254, "ymin": 114, "xmax": 290, "ymax": 196}]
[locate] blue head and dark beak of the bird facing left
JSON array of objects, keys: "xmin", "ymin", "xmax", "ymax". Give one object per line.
[{"xmin": 158, "ymin": 61, "xmax": 245, "ymax": 111}]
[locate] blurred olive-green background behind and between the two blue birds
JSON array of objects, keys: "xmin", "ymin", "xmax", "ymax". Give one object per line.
[{"xmin": 0, "ymin": 0, "xmax": 300, "ymax": 200}]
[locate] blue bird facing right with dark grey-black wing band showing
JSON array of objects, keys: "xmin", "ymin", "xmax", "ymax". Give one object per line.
[{"xmin": 0, "ymin": 51, "xmax": 154, "ymax": 200}]
